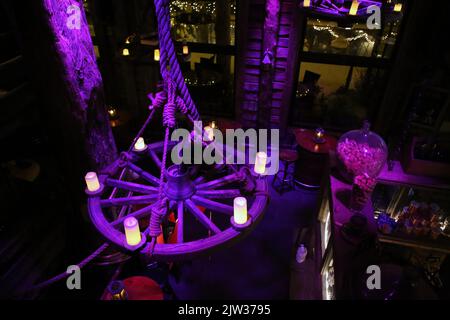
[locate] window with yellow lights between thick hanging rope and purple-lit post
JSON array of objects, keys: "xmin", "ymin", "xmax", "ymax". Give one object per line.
[{"xmin": 170, "ymin": 0, "xmax": 236, "ymax": 117}]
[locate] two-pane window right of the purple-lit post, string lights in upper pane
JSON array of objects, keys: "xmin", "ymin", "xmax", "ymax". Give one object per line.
[{"xmin": 289, "ymin": 9, "xmax": 403, "ymax": 131}]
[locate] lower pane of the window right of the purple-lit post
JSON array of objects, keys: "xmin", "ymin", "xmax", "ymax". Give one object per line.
[{"xmin": 292, "ymin": 62, "xmax": 384, "ymax": 129}]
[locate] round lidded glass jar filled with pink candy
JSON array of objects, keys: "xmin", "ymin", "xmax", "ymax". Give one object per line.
[{"xmin": 336, "ymin": 121, "xmax": 388, "ymax": 183}]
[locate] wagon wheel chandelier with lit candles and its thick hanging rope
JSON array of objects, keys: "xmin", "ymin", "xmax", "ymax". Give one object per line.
[{"xmin": 86, "ymin": 0, "xmax": 269, "ymax": 261}]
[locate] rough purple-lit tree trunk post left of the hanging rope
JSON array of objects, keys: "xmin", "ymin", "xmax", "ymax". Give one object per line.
[{"xmin": 42, "ymin": 0, "xmax": 117, "ymax": 170}]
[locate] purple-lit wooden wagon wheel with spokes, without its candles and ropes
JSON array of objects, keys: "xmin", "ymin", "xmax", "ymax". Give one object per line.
[{"xmin": 88, "ymin": 142, "xmax": 268, "ymax": 261}]
